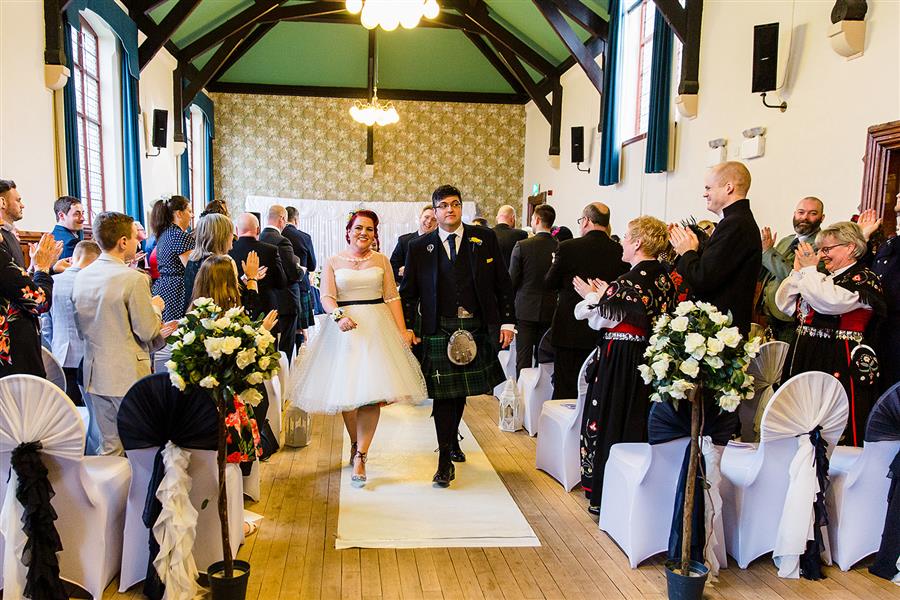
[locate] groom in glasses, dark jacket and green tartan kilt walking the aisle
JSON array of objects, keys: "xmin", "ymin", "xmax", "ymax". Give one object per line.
[{"xmin": 400, "ymin": 185, "xmax": 516, "ymax": 487}]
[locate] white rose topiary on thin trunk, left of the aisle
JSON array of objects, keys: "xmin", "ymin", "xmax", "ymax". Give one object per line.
[{"xmin": 166, "ymin": 298, "xmax": 280, "ymax": 577}]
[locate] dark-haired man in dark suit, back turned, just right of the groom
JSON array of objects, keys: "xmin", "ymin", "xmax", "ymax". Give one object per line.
[{"xmin": 509, "ymin": 204, "xmax": 557, "ymax": 377}]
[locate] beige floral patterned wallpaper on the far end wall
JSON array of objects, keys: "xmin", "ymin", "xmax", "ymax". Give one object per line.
[{"xmin": 212, "ymin": 94, "xmax": 525, "ymax": 220}]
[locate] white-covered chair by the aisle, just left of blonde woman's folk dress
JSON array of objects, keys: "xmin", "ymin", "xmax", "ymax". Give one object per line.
[{"xmin": 535, "ymin": 352, "xmax": 594, "ymax": 490}]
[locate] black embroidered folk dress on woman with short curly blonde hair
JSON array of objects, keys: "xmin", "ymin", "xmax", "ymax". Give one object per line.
[{"xmin": 575, "ymin": 260, "xmax": 674, "ymax": 506}]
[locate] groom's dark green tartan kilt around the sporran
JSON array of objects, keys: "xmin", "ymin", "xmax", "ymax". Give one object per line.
[{"xmin": 422, "ymin": 317, "xmax": 506, "ymax": 400}]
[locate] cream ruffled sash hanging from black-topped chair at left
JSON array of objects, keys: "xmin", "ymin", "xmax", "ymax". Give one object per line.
[{"xmin": 153, "ymin": 442, "xmax": 199, "ymax": 600}]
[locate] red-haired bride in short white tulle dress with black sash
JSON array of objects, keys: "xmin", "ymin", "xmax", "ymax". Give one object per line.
[{"xmin": 291, "ymin": 210, "xmax": 428, "ymax": 487}]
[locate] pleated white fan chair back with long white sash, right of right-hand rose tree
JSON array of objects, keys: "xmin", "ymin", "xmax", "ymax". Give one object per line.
[{"xmin": 761, "ymin": 372, "xmax": 849, "ymax": 579}]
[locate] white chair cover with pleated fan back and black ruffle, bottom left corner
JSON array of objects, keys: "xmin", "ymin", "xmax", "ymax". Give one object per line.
[{"xmin": 0, "ymin": 375, "xmax": 131, "ymax": 598}]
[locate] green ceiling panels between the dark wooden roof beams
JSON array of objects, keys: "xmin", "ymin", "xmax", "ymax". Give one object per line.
[{"xmin": 149, "ymin": 0, "xmax": 608, "ymax": 94}]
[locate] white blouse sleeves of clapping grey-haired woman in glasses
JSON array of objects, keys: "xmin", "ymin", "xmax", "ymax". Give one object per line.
[{"xmin": 775, "ymin": 265, "xmax": 869, "ymax": 315}]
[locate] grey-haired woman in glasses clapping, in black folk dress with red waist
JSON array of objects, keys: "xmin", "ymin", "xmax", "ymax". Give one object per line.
[{"xmin": 775, "ymin": 221, "xmax": 884, "ymax": 446}]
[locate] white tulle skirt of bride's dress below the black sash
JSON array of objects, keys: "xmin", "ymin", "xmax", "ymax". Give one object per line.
[{"xmin": 289, "ymin": 304, "xmax": 428, "ymax": 414}]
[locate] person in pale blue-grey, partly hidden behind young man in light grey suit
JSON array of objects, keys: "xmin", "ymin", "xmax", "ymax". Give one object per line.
[{"xmin": 41, "ymin": 240, "xmax": 100, "ymax": 406}]
